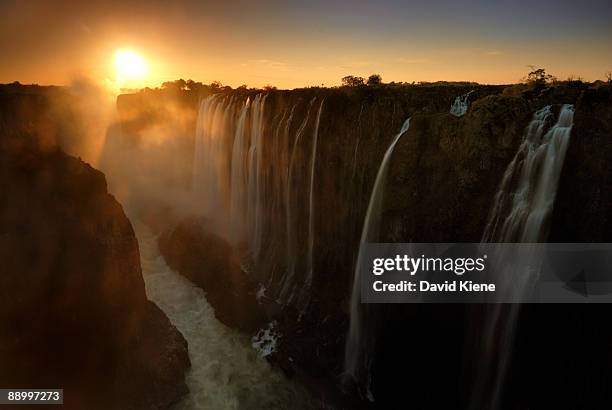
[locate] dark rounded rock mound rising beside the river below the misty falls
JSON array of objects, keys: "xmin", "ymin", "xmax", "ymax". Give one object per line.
[{"xmin": 159, "ymin": 218, "xmax": 266, "ymax": 332}]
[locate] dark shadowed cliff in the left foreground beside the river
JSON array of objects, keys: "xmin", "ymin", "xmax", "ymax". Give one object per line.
[{"xmin": 0, "ymin": 95, "xmax": 189, "ymax": 409}]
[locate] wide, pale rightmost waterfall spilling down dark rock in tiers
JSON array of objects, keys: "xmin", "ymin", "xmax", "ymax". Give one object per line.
[{"xmin": 474, "ymin": 104, "xmax": 574, "ymax": 409}]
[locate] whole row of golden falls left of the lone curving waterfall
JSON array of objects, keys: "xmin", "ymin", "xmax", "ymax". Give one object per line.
[{"xmin": 193, "ymin": 94, "xmax": 323, "ymax": 309}]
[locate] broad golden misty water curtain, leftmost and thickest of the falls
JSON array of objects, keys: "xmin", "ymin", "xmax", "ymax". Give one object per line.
[{"xmin": 192, "ymin": 94, "xmax": 266, "ymax": 247}]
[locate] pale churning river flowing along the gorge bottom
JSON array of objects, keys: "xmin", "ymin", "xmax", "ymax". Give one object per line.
[{"xmin": 134, "ymin": 223, "xmax": 316, "ymax": 410}]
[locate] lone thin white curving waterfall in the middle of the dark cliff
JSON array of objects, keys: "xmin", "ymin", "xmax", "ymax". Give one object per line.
[{"xmin": 344, "ymin": 118, "xmax": 410, "ymax": 401}]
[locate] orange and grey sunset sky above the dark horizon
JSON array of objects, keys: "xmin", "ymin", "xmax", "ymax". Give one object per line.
[{"xmin": 0, "ymin": 0, "xmax": 612, "ymax": 88}]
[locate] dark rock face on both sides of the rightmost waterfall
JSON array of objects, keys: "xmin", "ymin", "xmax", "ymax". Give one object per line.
[{"xmin": 372, "ymin": 87, "xmax": 612, "ymax": 409}]
